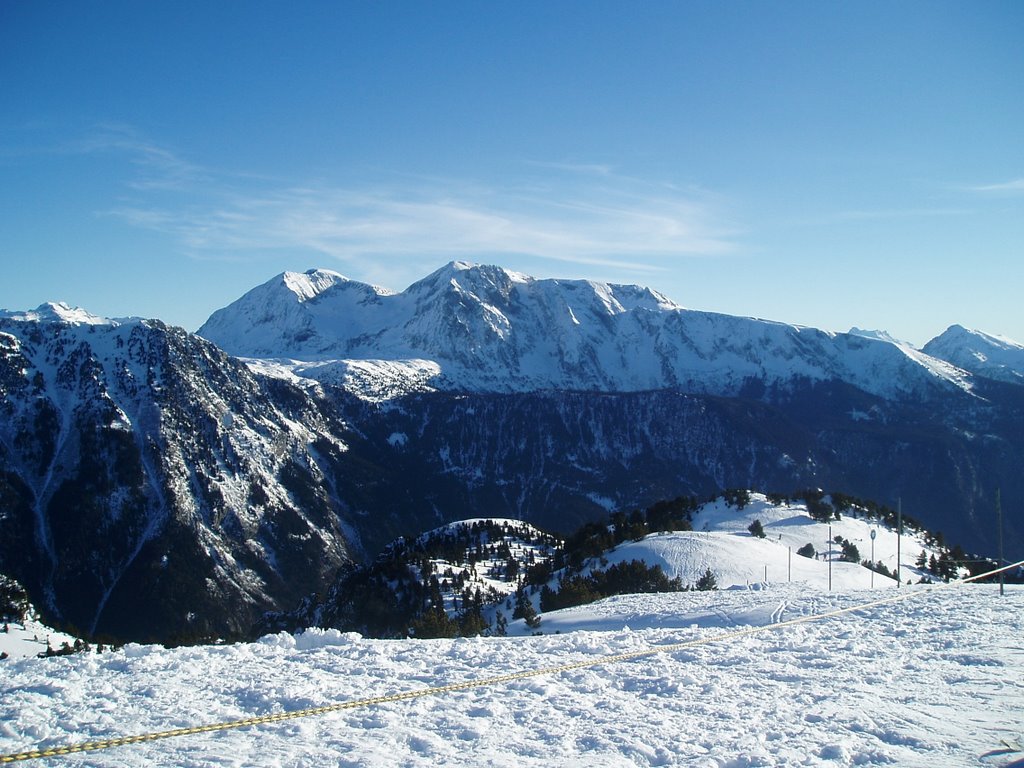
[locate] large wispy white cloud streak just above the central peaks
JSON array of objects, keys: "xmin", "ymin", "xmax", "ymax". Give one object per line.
[{"xmin": 87, "ymin": 130, "xmax": 735, "ymax": 270}]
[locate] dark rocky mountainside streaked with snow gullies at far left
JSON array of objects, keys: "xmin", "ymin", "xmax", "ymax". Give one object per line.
[{"xmin": 0, "ymin": 305, "xmax": 360, "ymax": 640}]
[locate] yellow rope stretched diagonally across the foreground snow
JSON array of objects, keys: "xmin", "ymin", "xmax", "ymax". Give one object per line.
[{"xmin": 0, "ymin": 560, "xmax": 1024, "ymax": 764}]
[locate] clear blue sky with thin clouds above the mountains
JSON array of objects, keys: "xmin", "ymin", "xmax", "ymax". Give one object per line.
[{"xmin": 0, "ymin": 0, "xmax": 1024, "ymax": 344}]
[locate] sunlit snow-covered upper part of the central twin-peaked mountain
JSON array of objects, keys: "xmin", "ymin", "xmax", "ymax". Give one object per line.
[{"xmin": 199, "ymin": 262, "xmax": 971, "ymax": 397}]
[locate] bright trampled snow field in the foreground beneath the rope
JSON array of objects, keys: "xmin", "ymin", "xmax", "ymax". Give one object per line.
[{"xmin": 0, "ymin": 583, "xmax": 1024, "ymax": 768}]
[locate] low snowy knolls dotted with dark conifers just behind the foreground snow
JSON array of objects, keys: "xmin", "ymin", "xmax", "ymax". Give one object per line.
[{"xmin": 276, "ymin": 492, "xmax": 954, "ymax": 637}]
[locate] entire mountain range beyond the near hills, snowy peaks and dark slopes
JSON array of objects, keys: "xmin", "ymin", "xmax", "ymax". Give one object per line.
[{"xmin": 0, "ymin": 263, "xmax": 1024, "ymax": 640}]
